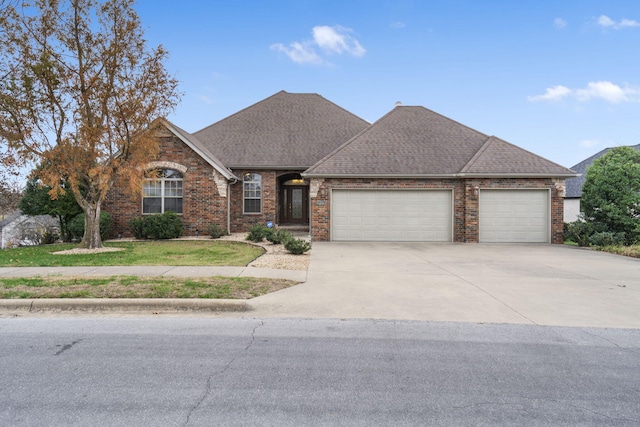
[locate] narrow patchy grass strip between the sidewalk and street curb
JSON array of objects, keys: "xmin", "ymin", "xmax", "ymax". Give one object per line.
[{"xmin": 0, "ymin": 276, "xmax": 297, "ymax": 299}]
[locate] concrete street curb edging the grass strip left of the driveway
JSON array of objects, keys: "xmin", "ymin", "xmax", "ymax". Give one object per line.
[{"xmin": 0, "ymin": 298, "xmax": 251, "ymax": 314}]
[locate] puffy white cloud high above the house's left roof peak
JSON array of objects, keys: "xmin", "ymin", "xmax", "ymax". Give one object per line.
[{"xmin": 271, "ymin": 25, "xmax": 366, "ymax": 65}]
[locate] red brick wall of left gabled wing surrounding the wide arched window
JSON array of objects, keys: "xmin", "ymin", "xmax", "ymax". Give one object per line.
[{"xmin": 103, "ymin": 129, "xmax": 227, "ymax": 241}]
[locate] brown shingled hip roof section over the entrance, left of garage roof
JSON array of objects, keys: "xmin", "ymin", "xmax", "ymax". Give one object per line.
[{"xmin": 194, "ymin": 91, "xmax": 369, "ymax": 169}]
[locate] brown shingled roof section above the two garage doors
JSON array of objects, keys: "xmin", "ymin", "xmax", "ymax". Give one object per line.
[{"xmin": 303, "ymin": 106, "xmax": 576, "ymax": 177}]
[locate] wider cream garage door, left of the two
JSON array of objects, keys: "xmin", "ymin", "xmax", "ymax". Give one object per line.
[{"xmin": 331, "ymin": 190, "xmax": 453, "ymax": 242}]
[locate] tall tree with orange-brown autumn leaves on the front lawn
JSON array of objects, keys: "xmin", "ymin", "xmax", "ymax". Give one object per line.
[{"xmin": 0, "ymin": 0, "xmax": 179, "ymax": 248}]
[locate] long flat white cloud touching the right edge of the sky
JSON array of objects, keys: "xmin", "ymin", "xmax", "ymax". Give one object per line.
[{"xmin": 527, "ymin": 81, "xmax": 640, "ymax": 104}]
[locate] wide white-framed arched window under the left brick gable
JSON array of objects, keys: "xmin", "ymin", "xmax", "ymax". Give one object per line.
[{"xmin": 142, "ymin": 169, "xmax": 182, "ymax": 214}]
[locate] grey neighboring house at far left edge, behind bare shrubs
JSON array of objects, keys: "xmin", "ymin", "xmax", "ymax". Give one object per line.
[{"xmin": 0, "ymin": 211, "xmax": 59, "ymax": 249}]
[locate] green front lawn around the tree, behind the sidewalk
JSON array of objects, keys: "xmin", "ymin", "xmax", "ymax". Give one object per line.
[{"xmin": 0, "ymin": 240, "xmax": 264, "ymax": 267}]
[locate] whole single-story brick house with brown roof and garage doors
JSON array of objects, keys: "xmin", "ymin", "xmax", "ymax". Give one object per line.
[{"xmin": 104, "ymin": 91, "xmax": 576, "ymax": 243}]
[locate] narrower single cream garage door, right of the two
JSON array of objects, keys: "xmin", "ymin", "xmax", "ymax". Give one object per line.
[{"xmin": 479, "ymin": 190, "xmax": 550, "ymax": 243}]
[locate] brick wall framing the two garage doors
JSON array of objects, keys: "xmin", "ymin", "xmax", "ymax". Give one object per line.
[{"xmin": 311, "ymin": 178, "xmax": 564, "ymax": 243}]
